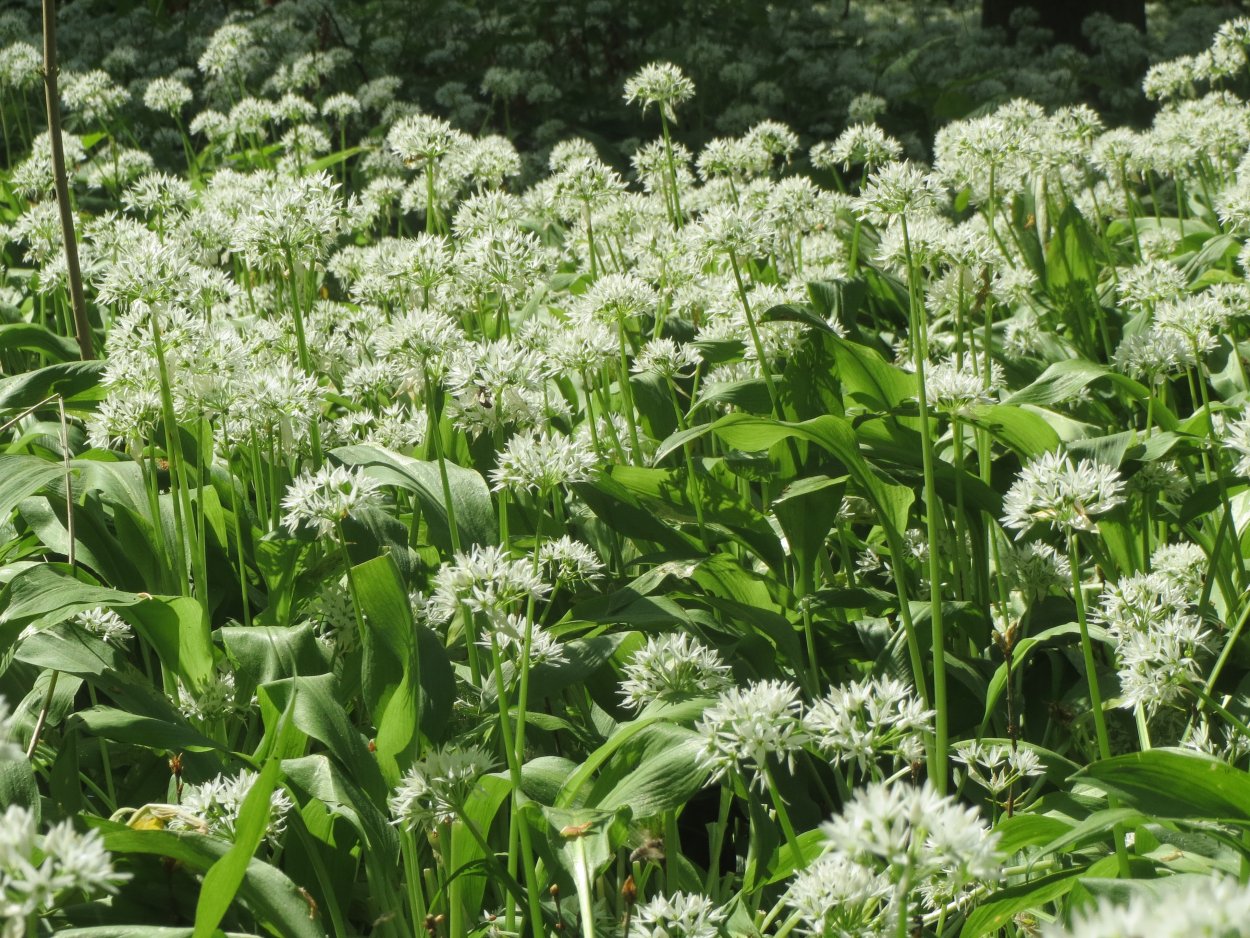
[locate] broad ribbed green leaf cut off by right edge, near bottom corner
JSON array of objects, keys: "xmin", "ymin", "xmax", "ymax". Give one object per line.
[{"xmin": 1073, "ymin": 749, "xmax": 1250, "ymax": 823}]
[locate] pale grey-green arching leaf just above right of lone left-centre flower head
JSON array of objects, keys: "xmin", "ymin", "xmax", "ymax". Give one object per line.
[{"xmin": 331, "ymin": 444, "xmax": 496, "ymax": 550}]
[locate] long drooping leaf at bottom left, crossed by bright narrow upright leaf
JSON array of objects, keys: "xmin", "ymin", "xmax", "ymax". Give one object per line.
[{"xmin": 98, "ymin": 818, "xmax": 325, "ymax": 938}]
